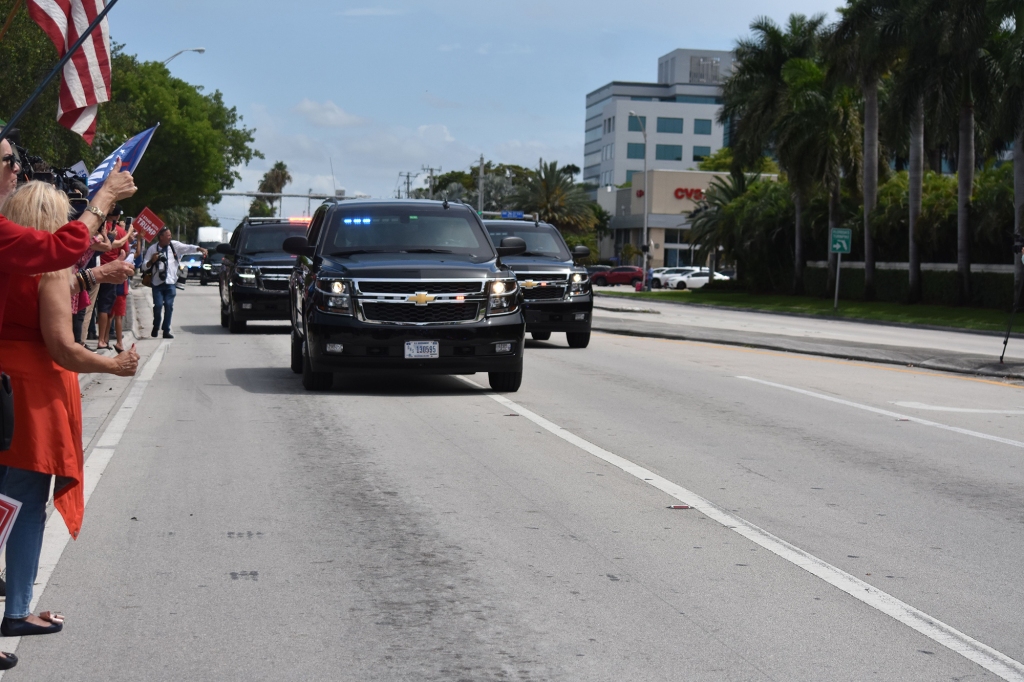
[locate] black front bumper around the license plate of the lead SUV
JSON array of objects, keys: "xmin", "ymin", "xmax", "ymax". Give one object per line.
[{"xmin": 306, "ymin": 311, "xmax": 525, "ymax": 374}]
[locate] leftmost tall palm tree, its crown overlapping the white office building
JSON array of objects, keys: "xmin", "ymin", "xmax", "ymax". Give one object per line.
[{"xmin": 718, "ymin": 14, "xmax": 825, "ymax": 293}]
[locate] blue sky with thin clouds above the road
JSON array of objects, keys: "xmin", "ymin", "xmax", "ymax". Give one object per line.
[{"xmin": 110, "ymin": 0, "xmax": 839, "ymax": 225}]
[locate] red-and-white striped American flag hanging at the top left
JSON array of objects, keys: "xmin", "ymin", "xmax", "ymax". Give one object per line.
[{"xmin": 28, "ymin": 0, "xmax": 111, "ymax": 144}]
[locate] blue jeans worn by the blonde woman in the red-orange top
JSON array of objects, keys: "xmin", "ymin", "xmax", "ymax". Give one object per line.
[{"xmin": 0, "ymin": 467, "xmax": 52, "ymax": 620}]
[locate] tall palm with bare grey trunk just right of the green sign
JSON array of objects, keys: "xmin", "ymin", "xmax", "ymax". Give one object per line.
[{"xmin": 825, "ymin": 0, "xmax": 896, "ymax": 300}]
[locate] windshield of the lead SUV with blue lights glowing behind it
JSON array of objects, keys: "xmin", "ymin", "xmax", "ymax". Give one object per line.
[{"xmin": 322, "ymin": 205, "xmax": 495, "ymax": 262}]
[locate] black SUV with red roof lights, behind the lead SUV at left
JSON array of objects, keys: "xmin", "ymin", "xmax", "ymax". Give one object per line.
[{"xmin": 216, "ymin": 218, "xmax": 309, "ymax": 334}]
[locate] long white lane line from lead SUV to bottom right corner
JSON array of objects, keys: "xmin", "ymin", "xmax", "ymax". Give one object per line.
[{"xmin": 458, "ymin": 377, "xmax": 1024, "ymax": 682}]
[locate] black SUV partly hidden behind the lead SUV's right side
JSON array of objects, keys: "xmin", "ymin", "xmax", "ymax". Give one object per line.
[{"xmin": 483, "ymin": 220, "xmax": 594, "ymax": 348}]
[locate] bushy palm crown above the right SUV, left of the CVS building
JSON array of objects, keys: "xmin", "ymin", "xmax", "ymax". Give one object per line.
[{"xmin": 512, "ymin": 159, "xmax": 597, "ymax": 232}]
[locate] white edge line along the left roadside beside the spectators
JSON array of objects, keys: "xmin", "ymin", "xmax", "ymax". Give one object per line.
[{"xmin": 0, "ymin": 341, "xmax": 171, "ymax": 679}]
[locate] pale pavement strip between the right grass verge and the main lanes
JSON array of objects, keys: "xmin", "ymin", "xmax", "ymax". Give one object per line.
[{"xmin": 593, "ymin": 295, "xmax": 1024, "ymax": 380}]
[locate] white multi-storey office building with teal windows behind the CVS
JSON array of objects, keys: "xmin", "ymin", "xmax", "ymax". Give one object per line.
[{"xmin": 583, "ymin": 49, "xmax": 734, "ymax": 213}]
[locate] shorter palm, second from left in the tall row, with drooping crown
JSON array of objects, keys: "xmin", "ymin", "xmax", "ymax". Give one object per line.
[{"xmin": 777, "ymin": 59, "xmax": 861, "ymax": 292}]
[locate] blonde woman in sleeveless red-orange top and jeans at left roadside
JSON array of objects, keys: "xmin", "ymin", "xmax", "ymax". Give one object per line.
[{"xmin": 0, "ymin": 181, "xmax": 138, "ymax": 655}]
